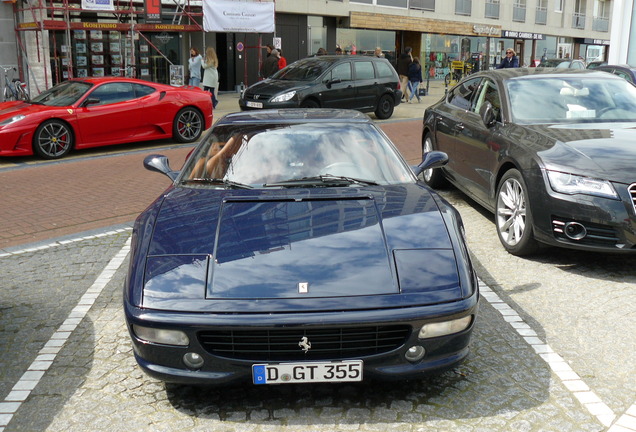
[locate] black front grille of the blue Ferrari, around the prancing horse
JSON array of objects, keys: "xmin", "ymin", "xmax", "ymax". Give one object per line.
[{"xmin": 198, "ymin": 325, "xmax": 411, "ymax": 361}]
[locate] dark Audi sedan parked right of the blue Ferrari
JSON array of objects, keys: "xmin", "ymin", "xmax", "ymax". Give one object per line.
[{"xmin": 422, "ymin": 68, "xmax": 636, "ymax": 255}]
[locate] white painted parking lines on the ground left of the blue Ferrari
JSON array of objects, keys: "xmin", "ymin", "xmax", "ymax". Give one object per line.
[{"xmin": 0, "ymin": 238, "xmax": 132, "ymax": 432}]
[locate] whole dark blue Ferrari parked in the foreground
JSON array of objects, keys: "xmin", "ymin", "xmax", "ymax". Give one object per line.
[{"xmin": 124, "ymin": 109, "xmax": 479, "ymax": 385}]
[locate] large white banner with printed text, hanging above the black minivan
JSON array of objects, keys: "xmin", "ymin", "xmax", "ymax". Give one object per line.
[{"xmin": 203, "ymin": 0, "xmax": 274, "ymax": 33}]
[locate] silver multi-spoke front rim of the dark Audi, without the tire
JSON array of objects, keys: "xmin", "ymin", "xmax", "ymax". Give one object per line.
[{"xmin": 497, "ymin": 178, "xmax": 526, "ymax": 246}]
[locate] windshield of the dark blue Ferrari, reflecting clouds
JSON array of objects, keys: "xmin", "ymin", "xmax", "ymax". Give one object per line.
[{"xmin": 181, "ymin": 123, "xmax": 415, "ymax": 187}]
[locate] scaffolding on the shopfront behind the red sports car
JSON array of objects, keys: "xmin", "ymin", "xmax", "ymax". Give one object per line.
[{"xmin": 13, "ymin": 0, "xmax": 203, "ymax": 93}]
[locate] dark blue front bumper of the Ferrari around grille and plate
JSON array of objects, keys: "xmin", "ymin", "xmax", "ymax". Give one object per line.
[{"xmin": 125, "ymin": 292, "xmax": 479, "ymax": 385}]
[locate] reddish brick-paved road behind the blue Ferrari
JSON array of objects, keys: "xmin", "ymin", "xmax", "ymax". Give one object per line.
[{"xmin": 0, "ymin": 84, "xmax": 443, "ymax": 252}]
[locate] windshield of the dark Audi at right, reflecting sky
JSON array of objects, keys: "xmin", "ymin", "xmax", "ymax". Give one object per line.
[{"xmin": 506, "ymin": 75, "xmax": 636, "ymax": 124}]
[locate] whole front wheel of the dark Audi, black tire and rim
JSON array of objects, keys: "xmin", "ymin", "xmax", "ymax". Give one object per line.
[{"xmin": 495, "ymin": 169, "xmax": 539, "ymax": 256}]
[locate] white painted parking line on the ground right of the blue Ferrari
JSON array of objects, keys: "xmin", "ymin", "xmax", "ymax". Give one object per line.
[{"xmin": 479, "ymin": 280, "xmax": 620, "ymax": 432}]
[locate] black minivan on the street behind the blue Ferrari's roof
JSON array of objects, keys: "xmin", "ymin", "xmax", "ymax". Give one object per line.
[{"xmin": 239, "ymin": 55, "xmax": 402, "ymax": 119}]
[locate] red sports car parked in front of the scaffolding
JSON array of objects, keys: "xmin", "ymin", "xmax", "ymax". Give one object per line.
[{"xmin": 0, "ymin": 78, "xmax": 212, "ymax": 159}]
